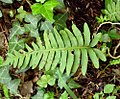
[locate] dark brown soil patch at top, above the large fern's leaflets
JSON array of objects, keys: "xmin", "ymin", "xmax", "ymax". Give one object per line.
[{"xmin": 64, "ymin": 0, "xmax": 104, "ymax": 33}]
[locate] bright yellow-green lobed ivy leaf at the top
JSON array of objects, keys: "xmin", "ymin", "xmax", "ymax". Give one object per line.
[{"xmin": 31, "ymin": 0, "xmax": 59, "ymax": 22}]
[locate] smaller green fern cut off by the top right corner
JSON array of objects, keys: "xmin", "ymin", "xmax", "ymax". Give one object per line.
[{"xmin": 102, "ymin": 0, "xmax": 120, "ymax": 22}]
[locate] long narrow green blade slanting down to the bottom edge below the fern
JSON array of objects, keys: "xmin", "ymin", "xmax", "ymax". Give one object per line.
[{"xmin": 58, "ymin": 69, "xmax": 78, "ymax": 99}]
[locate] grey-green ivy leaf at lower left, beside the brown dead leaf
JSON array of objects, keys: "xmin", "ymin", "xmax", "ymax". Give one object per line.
[{"xmin": 7, "ymin": 79, "xmax": 20, "ymax": 94}]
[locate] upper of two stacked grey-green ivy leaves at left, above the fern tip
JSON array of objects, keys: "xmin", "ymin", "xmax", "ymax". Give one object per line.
[{"xmin": 9, "ymin": 21, "xmax": 25, "ymax": 39}]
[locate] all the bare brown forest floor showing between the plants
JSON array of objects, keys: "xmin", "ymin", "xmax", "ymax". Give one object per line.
[{"xmin": 0, "ymin": 0, "xmax": 120, "ymax": 99}]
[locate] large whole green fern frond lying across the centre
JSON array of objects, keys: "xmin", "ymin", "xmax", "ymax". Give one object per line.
[{"xmin": 7, "ymin": 23, "xmax": 106, "ymax": 75}]
